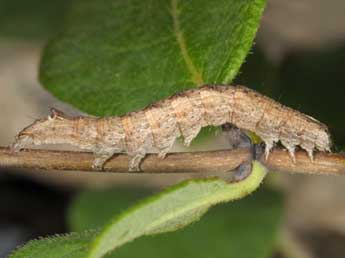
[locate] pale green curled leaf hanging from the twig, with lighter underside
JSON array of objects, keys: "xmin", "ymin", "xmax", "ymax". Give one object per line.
[{"xmin": 88, "ymin": 161, "xmax": 266, "ymax": 258}]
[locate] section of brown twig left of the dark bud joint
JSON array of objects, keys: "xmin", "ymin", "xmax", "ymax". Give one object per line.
[{"xmin": 0, "ymin": 148, "xmax": 249, "ymax": 173}]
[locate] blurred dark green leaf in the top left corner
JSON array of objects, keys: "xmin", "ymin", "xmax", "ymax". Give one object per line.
[{"xmin": 0, "ymin": 0, "xmax": 71, "ymax": 39}]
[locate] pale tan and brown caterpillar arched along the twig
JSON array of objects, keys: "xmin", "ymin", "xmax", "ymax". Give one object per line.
[{"xmin": 11, "ymin": 85, "xmax": 331, "ymax": 171}]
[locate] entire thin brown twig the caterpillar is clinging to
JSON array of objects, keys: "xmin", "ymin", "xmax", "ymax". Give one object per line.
[{"xmin": 0, "ymin": 147, "xmax": 345, "ymax": 175}]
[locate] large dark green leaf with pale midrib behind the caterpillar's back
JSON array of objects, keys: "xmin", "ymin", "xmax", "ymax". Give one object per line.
[{"xmin": 40, "ymin": 0, "xmax": 266, "ymax": 116}]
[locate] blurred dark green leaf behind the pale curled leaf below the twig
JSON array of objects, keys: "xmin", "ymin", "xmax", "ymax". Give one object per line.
[{"xmin": 70, "ymin": 182, "xmax": 283, "ymax": 258}]
